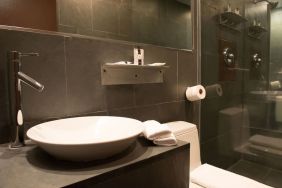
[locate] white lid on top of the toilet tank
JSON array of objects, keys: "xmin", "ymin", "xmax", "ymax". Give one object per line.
[{"xmin": 164, "ymin": 121, "xmax": 197, "ymax": 136}]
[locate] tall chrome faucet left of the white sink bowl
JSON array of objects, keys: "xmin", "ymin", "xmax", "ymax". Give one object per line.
[{"xmin": 8, "ymin": 51, "xmax": 44, "ymax": 148}]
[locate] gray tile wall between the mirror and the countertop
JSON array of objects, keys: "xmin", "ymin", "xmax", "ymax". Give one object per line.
[{"xmin": 0, "ymin": 29, "xmax": 199, "ymax": 143}]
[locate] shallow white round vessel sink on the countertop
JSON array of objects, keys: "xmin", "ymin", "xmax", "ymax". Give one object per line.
[{"xmin": 27, "ymin": 116, "xmax": 143, "ymax": 161}]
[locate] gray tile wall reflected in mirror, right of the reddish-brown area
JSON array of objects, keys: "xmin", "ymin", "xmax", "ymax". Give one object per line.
[{"xmin": 57, "ymin": 0, "xmax": 192, "ymax": 49}]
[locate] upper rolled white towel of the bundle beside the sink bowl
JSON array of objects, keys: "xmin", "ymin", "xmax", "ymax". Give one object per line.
[{"xmin": 143, "ymin": 120, "xmax": 171, "ymax": 140}]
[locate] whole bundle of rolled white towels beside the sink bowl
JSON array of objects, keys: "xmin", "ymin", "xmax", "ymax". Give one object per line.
[{"xmin": 143, "ymin": 120, "xmax": 177, "ymax": 146}]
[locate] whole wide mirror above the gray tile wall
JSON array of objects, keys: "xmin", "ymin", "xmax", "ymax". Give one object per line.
[{"xmin": 0, "ymin": 0, "xmax": 193, "ymax": 49}]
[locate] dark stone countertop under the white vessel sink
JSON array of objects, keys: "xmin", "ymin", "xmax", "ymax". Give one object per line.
[{"xmin": 0, "ymin": 138, "xmax": 189, "ymax": 188}]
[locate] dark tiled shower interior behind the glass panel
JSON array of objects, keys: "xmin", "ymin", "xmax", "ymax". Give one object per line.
[{"xmin": 200, "ymin": 0, "xmax": 282, "ymax": 187}]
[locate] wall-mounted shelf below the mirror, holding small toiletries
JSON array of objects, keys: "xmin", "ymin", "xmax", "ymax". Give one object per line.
[{"xmin": 101, "ymin": 65, "xmax": 169, "ymax": 85}]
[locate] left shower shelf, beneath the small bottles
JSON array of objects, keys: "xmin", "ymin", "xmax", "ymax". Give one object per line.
[{"xmin": 219, "ymin": 12, "xmax": 248, "ymax": 32}]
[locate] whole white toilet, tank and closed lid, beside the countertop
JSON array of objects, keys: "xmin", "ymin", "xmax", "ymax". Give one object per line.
[{"xmin": 166, "ymin": 121, "xmax": 270, "ymax": 188}]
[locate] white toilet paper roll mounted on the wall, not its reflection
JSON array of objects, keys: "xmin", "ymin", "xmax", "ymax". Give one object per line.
[{"xmin": 186, "ymin": 85, "xmax": 206, "ymax": 101}]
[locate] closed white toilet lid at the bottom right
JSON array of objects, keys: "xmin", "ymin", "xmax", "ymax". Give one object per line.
[{"xmin": 190, "ymin": 164, "xmax": 271, "ymax": 188}]
